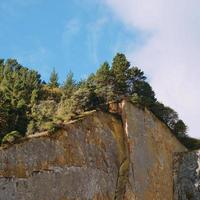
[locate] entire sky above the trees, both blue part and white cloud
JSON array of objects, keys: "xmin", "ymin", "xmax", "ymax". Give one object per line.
[{"xmin": 0, "ymin": 0, "xmax": 200, "ymax": 138}]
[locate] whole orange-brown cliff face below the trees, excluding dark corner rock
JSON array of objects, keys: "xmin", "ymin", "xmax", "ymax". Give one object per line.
[{"xmin": 0, "ymin": 101, "xmax": 187, "ymax": 200}]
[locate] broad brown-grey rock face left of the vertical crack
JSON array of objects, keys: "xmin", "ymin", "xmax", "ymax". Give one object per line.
[{"xmin": 0, "ymin": 112, "xmax": 126, "ymax": 200}]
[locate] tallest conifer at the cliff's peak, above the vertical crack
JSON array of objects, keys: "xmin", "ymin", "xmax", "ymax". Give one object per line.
[{"xmin": 111, "ymin": 53, "xmax": 130, "ymax": 96}]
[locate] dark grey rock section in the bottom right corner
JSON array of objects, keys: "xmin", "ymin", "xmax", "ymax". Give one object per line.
[{"xmin": 174, "ymin": 151, "xmax": 200, "ymax": 200}]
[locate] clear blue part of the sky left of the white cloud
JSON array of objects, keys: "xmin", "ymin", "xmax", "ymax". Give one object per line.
[{"xmin": 0, "ymin": 0, "xmax": 145, "ymax": 83}]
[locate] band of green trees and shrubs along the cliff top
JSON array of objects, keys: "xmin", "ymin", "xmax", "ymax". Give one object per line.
[{"xmin": 0, "ymin": 53, "xmax": 197, "ymax": 148}]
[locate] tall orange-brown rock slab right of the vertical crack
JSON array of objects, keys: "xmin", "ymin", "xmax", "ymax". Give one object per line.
[{"xmin": 122, "ymin": 101, "xmax": 186, "ymax": 200}]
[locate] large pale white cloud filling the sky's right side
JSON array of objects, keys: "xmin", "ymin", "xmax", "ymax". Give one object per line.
[{"xmin": 105, "ymin": 0, "xmax": 200, "ymax": 138}]
